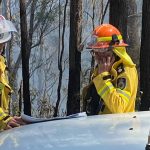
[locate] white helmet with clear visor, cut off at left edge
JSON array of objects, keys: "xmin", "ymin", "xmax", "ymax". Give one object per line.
[{"xmin": 0, "ymin": 15, "xmax": 17, "ymax": 43}]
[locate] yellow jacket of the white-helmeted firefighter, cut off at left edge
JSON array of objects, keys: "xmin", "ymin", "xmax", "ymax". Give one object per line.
[{"xmin": 0, "ymin": 55, "xmax": 12, "ymax": 130}]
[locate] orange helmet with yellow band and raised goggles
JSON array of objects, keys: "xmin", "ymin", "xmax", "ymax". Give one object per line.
[{"xmin": 87, "ymin": 24, "xmax": 128, "ymax": 49}]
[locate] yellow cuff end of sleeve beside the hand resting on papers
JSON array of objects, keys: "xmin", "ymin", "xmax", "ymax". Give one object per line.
[{"xmin": 0, "ymin": 108, "xmax": 12, "ymax": 131}]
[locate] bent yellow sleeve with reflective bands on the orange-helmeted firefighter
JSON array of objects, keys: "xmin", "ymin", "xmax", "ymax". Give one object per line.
[{"xmin": 93, "ymin": 72, "xmax": 131, "ymax": 113}]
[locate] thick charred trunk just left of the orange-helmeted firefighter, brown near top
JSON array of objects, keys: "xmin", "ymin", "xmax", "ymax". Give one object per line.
[{"xmin": 67, "ymin": 0, "xmax": 82, "ymax": 115}]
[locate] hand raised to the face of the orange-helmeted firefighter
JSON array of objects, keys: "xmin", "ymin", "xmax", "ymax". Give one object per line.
[{"xmin": 98, "ymin": 55, "xmax": 115, "ymax": 74}]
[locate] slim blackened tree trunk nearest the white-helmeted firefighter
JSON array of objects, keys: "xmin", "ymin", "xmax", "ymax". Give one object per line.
[{"xmin": 20, "ymin": 0, "xmax": 31, "ymax": 115}]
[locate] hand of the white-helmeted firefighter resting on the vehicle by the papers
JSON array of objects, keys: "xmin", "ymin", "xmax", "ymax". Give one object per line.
[{"xmin": 5, "ymin": 116, "xmax": 26, "ymax": 130}]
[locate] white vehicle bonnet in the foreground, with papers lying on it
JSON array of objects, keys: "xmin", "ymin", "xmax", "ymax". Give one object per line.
[{"xmin": 0, "ymin": 111, "xmax": 150, "ymax": 150}]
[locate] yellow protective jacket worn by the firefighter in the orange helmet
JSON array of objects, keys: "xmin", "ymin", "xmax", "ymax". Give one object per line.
[{"xmin": 93, "ymin": 48, "xmax": 138, "ymax": 114}]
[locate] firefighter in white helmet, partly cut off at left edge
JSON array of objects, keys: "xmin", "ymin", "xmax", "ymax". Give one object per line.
[{"xmin": 0, "ymin": 15, "xmax": 24, "ymax": 131}]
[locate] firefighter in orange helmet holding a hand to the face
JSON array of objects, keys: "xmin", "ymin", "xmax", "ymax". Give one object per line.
[{"xmin": 83, "ymin": 24, "xmax": 138, "ymax": 115}]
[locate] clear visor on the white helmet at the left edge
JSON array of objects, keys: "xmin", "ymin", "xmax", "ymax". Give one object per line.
[{"xmin": 0, "ymin": 20, "xmax": 17, "ymax": 34}]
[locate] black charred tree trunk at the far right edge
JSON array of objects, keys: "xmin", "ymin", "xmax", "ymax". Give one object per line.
[{"xmin": 140, "ymin": 0, "xmax": 150, "ymax": 110}]
